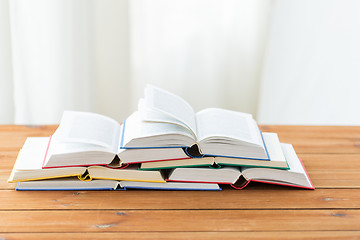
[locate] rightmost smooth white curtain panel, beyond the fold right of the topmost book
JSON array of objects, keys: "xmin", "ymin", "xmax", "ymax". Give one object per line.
[{"xmin": 258, "ymin": 0, "xmax": 360, "ymax": 125}]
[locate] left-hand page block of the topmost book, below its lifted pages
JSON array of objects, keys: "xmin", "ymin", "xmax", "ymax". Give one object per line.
[{"xmin": 120, "ymin": 112, "xmax": 195, "ymax": 148}]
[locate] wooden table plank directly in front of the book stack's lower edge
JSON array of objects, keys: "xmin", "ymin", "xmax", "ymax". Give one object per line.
[{"xmin": 0, "ymin": 187, "xmax": 360, "ymax": 210}]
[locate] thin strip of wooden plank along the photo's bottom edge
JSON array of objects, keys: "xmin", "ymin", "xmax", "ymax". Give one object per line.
[{"xmin": 0, "ymin": 231, "xmax": 360, "ymax": 240}]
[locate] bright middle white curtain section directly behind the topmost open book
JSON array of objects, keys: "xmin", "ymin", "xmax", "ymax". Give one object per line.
[{"xmin": 130, "ymin": 0, "xmax": 270, "ymax": 113}]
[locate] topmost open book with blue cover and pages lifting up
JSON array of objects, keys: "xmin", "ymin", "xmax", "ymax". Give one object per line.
[{"xmin": 121, "ymin": 85, "xmax": 269, "ymax": 160}]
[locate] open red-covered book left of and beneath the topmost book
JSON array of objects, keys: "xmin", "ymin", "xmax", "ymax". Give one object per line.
[{"xmin": 43, "ymin": 111, "xmax": 189, "ymax": 168}]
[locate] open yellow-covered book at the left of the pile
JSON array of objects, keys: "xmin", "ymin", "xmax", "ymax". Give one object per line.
[{"xmin": 8, "ymin": 137, "xmax": 165, "ymax": 182}]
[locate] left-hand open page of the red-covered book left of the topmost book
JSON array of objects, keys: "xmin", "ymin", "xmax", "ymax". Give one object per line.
[{"xmin": 52, "ymin": 111, "xmax": 121, "ymax": 153}]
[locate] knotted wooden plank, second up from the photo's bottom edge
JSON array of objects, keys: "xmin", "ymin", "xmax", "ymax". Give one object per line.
[{"xmin": 0, "ymin": 210, "xmax": 360, "ymax": 233}]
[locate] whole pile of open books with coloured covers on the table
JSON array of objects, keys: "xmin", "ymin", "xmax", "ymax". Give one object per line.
[{"xmin": 9, "ymin": 85, "xmax": 314, "ymax": 190}]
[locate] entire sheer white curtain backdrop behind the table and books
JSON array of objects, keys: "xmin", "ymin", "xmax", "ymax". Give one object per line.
[{"xmin": 0, "ymin": 0, "xmax": 360, "ymax": 124}]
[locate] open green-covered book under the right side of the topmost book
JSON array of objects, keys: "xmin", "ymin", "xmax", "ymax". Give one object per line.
[{"xmin": 140, "ymin": 133, "xmax": 289, "ymax": 170}]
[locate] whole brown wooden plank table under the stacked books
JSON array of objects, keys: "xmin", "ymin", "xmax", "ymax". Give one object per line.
[{"xmin": 0, "ymin": 125, "xmax": 360, "ymax": 239}]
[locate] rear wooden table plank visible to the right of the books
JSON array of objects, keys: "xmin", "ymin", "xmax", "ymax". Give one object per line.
[{"xmin": 260, "ymin": 125, "xmax": 360, "ymax": 153}]
